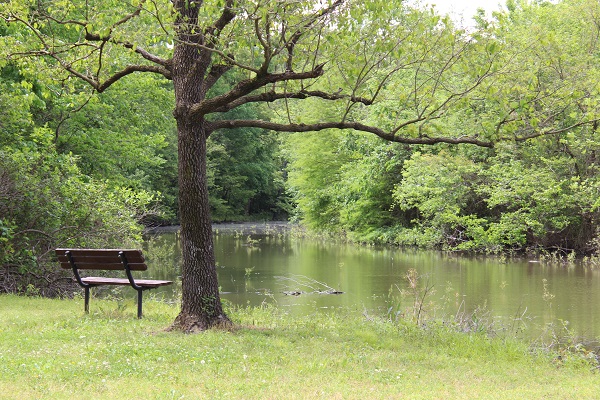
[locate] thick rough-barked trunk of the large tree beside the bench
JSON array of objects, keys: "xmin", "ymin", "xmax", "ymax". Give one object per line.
[{"xmin": 171, "ymin": 23, "xmax": 231, "ymax": 332}]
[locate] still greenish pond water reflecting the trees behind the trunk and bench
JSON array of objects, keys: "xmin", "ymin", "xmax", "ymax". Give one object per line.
[{"xmin": 139, "ymin": 226, "xmax": 600, "ymax": 340}]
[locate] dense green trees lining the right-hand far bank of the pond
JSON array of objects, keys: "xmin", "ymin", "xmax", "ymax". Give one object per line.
[{"xmin": 286, "ymin": 1, "xmax": 600, "ymax": 254}]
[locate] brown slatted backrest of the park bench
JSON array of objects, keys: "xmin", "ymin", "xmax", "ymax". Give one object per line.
[{"xmin": 56, "ymin": 249, "xmax": 148, "ymax": 271}]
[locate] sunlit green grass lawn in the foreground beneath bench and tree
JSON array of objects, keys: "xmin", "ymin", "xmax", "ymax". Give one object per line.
[{"xmin": 0, "ymin": 295, "xmax": 600, "ymax": 399}]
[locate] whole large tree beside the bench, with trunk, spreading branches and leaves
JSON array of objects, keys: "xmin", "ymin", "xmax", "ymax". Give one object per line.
[{"xmin": 0, "ymin": 0, "xmax": 588, "ymax": 332}]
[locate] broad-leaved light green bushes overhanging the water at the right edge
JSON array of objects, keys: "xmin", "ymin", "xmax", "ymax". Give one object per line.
[{"xmin": 395, "ymin": 140, "xmax": 599, "ymax": 253}]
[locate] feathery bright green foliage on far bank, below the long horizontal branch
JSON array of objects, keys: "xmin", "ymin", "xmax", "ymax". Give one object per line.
[{"xmin": 285, "ymin": 131, "xmax": 407, "ymax": 242}]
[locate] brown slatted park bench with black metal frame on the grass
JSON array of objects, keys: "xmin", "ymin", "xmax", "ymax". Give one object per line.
[{"xmin": 55, "ymin": 249, "xmax": 173, "ymax": 318}]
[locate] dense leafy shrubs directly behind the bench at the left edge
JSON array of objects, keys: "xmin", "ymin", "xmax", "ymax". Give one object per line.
[{"xmin": 0, "ymin": 60, "xmax": 157, "ymax": 295}]
